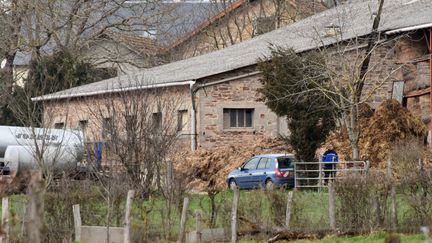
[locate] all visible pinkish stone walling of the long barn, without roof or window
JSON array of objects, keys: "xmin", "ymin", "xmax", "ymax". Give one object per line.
[{"xmin": 45, "ymin": 31, "xmax": 430, "ymax": 153}]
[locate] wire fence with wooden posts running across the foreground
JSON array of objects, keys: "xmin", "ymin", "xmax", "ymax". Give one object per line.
[{"xmin": 0, "ymin": 167, "xmax": 432, "ymax": 242}]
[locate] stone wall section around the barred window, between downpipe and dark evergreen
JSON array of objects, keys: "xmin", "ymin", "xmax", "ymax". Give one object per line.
[{"xmin": 197, "ymin": 71, "xmax": 288, "ymax": 149}]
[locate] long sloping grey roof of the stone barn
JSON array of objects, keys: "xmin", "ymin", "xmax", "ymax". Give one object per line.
[{"xmin": 36, "ymin": 0, "xmax": 432, "ymax": 100}]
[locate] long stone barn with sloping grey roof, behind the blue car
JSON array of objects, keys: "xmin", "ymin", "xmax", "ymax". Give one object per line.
[{"xmin": 34, "ymin": 0, "xmax": 432, "ymax": 156}]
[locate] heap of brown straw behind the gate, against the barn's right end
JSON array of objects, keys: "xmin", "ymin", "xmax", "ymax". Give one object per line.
[{"xmin": 326, "ymin": 100, "xmax": 427, "ymax": 168}]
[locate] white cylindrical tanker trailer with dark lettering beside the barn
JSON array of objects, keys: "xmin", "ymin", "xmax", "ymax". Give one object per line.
[{"xmin": 0, "ymin": 126, "xmax": 84, "ymax": 176}]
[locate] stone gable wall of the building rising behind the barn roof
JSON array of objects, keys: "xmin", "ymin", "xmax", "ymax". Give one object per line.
[{"xmin": 167, "ymin": 0, "xmax": 327, "ymax": 60}]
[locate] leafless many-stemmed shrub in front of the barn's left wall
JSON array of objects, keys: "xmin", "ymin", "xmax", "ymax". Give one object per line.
[{"xmin": 83, "ymin": 79, "xmax": 187, "ymax": 196}]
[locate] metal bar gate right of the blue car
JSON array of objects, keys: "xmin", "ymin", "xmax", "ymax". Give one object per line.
[{"xmin": 294, "ymin": 160, "xmax": 369, "ymax": 188}]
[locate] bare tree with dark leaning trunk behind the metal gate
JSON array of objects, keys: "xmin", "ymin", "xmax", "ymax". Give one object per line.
[{"xmin": 317, "ymin": 0, "xmax": 390, "ymax": 160}]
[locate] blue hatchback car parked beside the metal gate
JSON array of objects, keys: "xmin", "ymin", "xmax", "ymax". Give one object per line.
[{"xmin": 227, "ymin": 154, "xmax": 295, "ymax": 189}]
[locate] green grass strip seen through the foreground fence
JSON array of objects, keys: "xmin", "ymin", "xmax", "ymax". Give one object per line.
[{"xmin": 0, "ymin": 190, "xmax": 421, "ymax": 242}]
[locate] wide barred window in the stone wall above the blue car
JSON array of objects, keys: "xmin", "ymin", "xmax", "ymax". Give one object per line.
[{"xmin": 223, "ymin": 109, "xmax": 254, "ymax": 128}]
